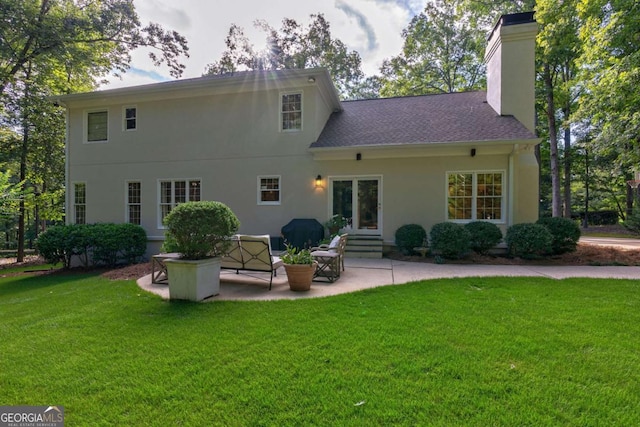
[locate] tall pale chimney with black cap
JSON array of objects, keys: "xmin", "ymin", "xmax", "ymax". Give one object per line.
[{"xmin": 484, "ymin": 12, "xmax": 538, "ymax": 134}]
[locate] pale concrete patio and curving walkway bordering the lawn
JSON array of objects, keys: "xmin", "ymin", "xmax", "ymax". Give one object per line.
[{"xmin": 138, "ymin": 258, "xmax": 640, "ymax": 301}]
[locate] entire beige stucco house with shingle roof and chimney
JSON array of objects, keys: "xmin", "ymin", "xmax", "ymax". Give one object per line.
[{"xmin": 57, "ymin": 13, "xmax": 540, "ymax": 254}]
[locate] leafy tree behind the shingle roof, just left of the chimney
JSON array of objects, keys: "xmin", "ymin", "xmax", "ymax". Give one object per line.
[{"xmin": 380, "ymin": 0, "xmax": 485, "ymax": 96}]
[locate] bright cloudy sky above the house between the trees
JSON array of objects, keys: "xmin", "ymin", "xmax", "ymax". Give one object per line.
[{"xmin": 101, "ymin": 0, "xmax": 427, "ymax": 89}]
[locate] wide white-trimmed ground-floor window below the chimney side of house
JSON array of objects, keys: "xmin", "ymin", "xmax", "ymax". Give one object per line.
[{"xmin": 447, "ymin": 172, "xmax": 505, "ymax": 221}]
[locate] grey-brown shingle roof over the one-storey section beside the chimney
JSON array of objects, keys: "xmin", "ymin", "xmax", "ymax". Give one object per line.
[{"xmin": 311, "ymin": 92, "xmax": 536, "ymax": 148}]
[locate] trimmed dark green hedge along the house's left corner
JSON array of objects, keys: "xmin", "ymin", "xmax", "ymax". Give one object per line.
[{"xmin": 36, "ymin": 223, "xmax": 147, "ymax": 269}]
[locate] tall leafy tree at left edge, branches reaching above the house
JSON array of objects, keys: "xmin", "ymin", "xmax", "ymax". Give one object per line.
[{"xmin": 0, "ymin": 0, "xmax": 188, "ymax": 261}]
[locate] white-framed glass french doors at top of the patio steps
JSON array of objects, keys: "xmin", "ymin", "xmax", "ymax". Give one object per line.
[{"xmin": 330, "ymin": 177, "xmax": 382, "ymax": 235}]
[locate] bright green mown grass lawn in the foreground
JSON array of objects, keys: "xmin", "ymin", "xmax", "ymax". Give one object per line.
[{"xmin": 0, "ymin": 272, "xmax": 640, "ymax": 426}]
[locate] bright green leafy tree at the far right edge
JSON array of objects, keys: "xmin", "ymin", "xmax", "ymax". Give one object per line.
[{"xmin": 576, "ymin": 0, "xmax": 640, "ymax": 215}]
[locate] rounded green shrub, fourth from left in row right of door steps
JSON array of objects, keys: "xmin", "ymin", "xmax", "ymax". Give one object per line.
[{"xmin": 504, "ymin": 223, "xmax": 553, "ymax": 258}]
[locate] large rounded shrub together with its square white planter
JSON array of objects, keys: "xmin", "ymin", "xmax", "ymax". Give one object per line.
[{"xmin": 163, "ymin": 201, "xmax": 240, "ymax": 301}]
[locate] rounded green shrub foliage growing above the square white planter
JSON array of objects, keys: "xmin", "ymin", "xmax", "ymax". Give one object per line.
[{"xmin": 163, "ymin": 201, "xmax": 240, "ymax": 260}]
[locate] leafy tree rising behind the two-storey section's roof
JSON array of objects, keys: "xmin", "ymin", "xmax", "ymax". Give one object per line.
[{"xmin": 205, "ymin": 14, "xmax": 364, "ymax": 99}]
